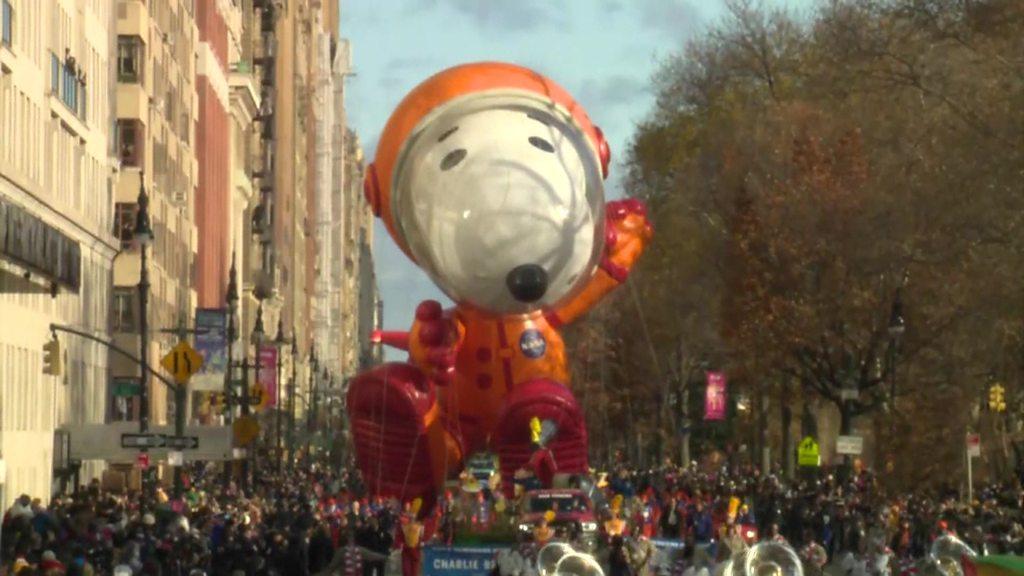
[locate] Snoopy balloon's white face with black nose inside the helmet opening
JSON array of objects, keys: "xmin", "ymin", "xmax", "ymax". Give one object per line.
[{"xmin": 392, "ymin": 93, "xmax": 604, "ymax": 314}]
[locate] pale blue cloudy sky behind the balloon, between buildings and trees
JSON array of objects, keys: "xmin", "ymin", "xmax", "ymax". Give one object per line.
[{"xmin": 341, "ymin": 0, "xmax": 811, "ymax": 359}]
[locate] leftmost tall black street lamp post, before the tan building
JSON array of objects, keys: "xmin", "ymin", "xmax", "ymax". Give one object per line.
[{"xmin": 133, "ymin": 170, "xmax": 154, "ymax": 507}]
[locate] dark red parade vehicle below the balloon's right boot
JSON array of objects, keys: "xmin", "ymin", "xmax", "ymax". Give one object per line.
[{"xmin": 518, "ymin": 490, "xmax": 597, "ymax": 548}]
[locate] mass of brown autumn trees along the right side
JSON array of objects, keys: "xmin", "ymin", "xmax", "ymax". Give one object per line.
[{"xmin": 574, "ymin": 0, "xmax": 1024, "ymax": 483}]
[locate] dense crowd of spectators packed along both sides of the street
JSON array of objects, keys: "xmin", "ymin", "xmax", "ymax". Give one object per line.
[{"xmin": 0, "ymin": 455, "xmax": 1024, "ymax": 576}]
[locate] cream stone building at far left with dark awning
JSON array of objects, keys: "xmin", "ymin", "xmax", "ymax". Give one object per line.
[{"xmin": 0, "ymin": 0, "xmax": 120, "ymax": 500}]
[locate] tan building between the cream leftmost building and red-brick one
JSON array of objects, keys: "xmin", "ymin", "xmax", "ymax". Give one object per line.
[{"xmin": 110, "ymin": 0, "xmax": 199, "ymax": 434}]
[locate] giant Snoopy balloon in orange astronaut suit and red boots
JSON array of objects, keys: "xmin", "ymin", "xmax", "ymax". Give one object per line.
[{"xmin": 348, "ymin": 63, "xmax": 651, "ymax": 498}]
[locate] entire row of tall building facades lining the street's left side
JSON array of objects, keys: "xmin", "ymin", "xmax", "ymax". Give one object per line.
[{"xmin": 0, "ymin": 0, "xmax": 379, "ymax": 498}]
